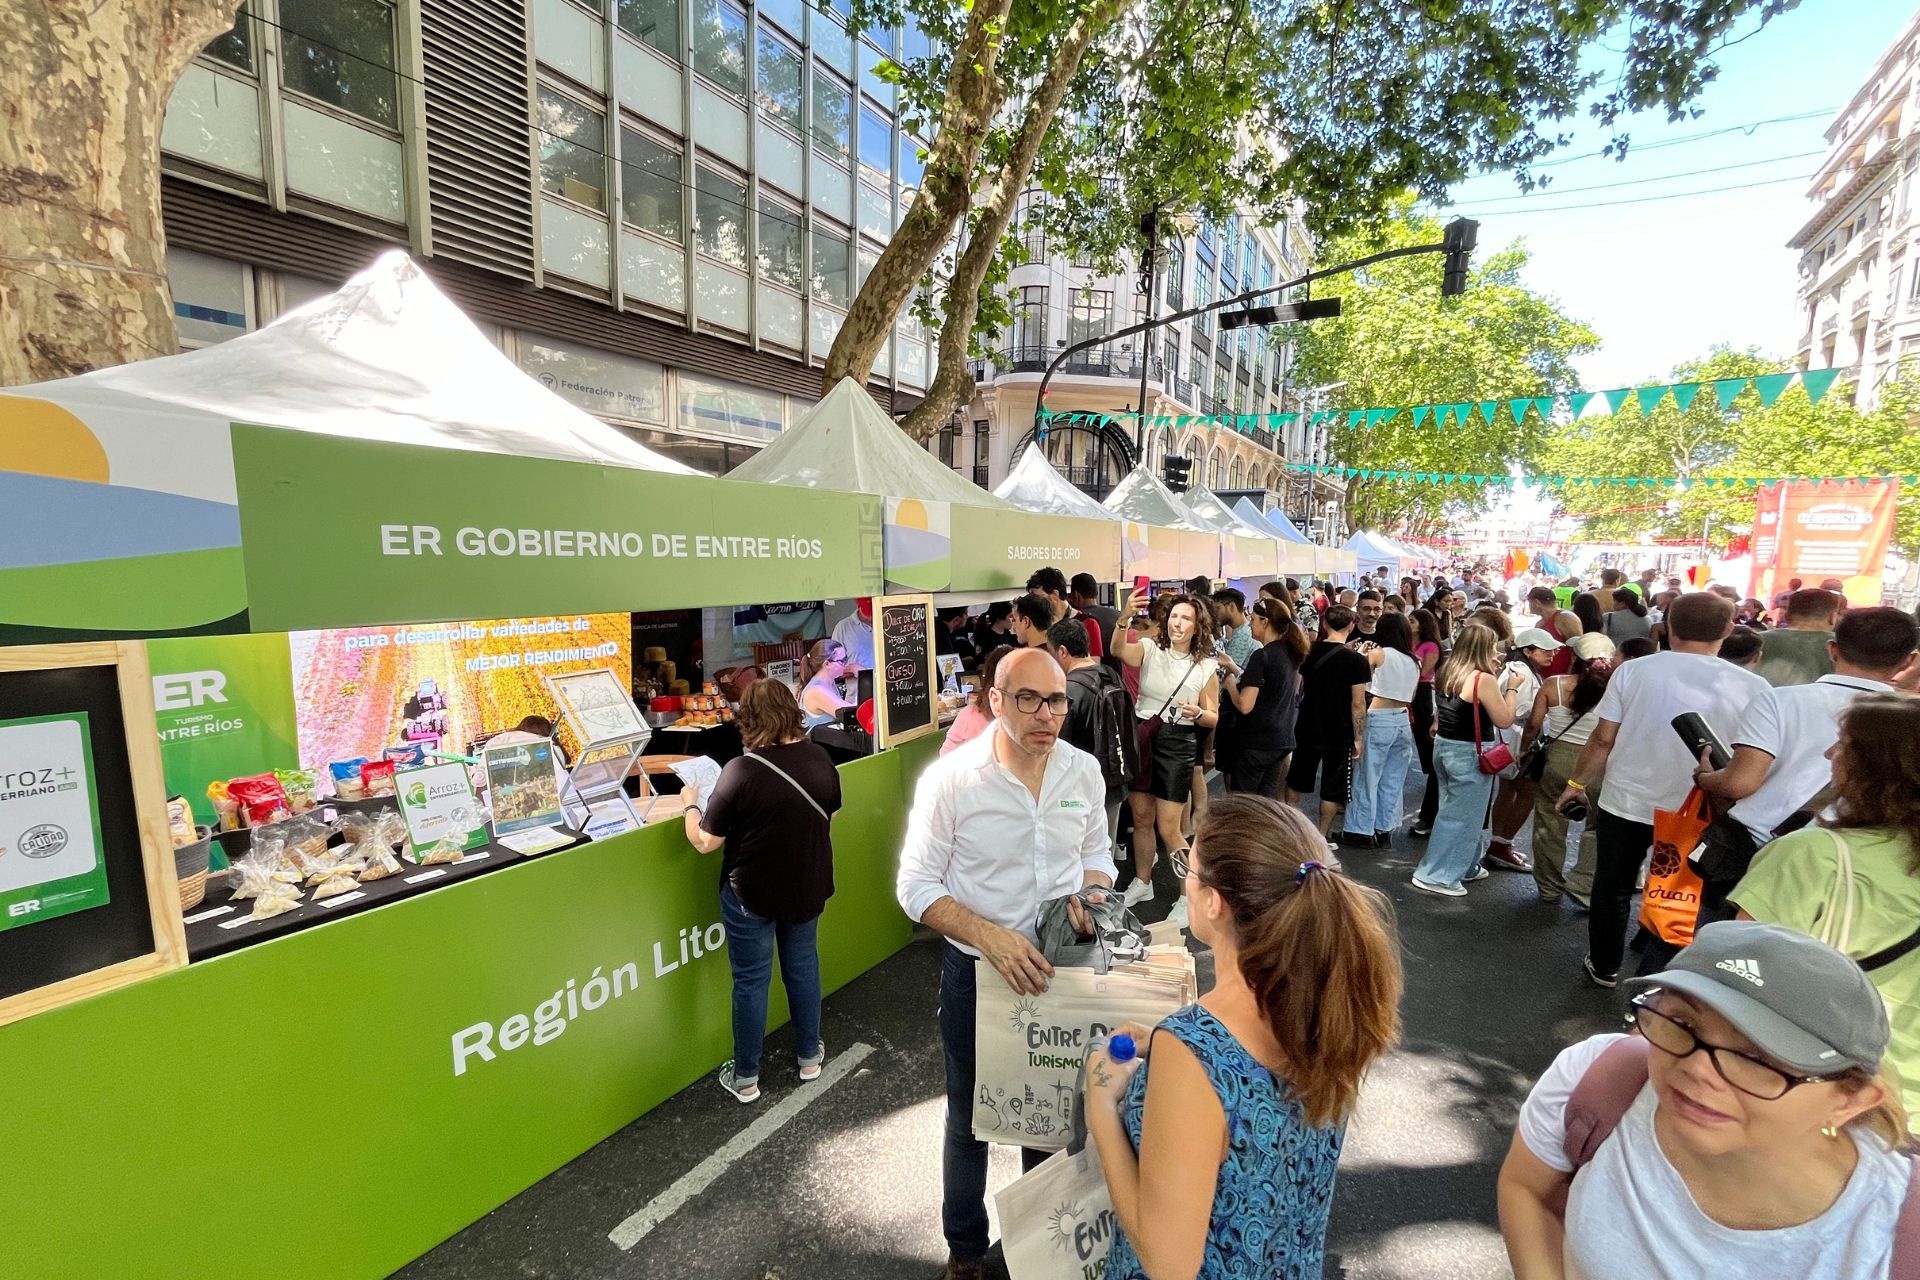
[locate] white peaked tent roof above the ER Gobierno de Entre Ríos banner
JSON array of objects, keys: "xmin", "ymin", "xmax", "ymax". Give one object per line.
[{"xmin": 10, "ymin": 249, "xmax": 699, "ymax": 475}]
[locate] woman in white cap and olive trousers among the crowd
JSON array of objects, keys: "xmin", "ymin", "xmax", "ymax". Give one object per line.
[{"xmin": 1521, "ymin": 633, "xmax": 1613, "ymax": 912}]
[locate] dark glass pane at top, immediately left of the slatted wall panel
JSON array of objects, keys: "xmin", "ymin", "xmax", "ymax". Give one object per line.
[{"xmin": 280, "ymin": 0, "xmax": 399, "ymax": 129}]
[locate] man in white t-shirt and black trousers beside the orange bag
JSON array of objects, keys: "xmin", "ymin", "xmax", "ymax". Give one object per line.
[{"xmin": 1559, "ymin": 591, "xmax": 1766, "ymax": 986}]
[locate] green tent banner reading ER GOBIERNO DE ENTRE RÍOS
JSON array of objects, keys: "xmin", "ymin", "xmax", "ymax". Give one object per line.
[{"xmin": 232, "ymin": 424, "xmax": 881, "ymax": 631}]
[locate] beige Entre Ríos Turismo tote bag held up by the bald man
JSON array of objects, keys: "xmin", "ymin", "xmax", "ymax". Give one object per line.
[{"xmin": 973, "ymin": 948, "xmax": 1198, "ymax": 1151}]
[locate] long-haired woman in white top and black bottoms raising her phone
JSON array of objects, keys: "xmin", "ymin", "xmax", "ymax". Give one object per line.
[{"xmin": 1114, "ymin": 591, "xmax": 1219, "ymax": 906}]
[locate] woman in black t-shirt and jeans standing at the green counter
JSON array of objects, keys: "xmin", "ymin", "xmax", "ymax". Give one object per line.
[{"xmin": 680, "ymin": 679, "xmax": 841, "ymax": 1102}]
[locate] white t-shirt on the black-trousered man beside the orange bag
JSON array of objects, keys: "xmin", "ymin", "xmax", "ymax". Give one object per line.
[{"xmin": 1599, "ymin": 652, "xmax": 1770, "ymax": 823}]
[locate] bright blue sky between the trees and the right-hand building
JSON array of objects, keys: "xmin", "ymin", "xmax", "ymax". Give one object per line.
[{"xmin": 1453, "ymin": 0, "xmax": 1916, "ymax": 390}]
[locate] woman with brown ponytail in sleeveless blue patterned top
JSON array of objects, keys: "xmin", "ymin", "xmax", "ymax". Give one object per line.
[{"xmin": 1087, "ymin": 794, "xmax": 1400, "ymax": 1280}]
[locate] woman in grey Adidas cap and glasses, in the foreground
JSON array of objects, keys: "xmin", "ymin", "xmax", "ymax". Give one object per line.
[{"xmin": 1500, "ymin": 919, "xmax": 1920, "ymax": 1280}]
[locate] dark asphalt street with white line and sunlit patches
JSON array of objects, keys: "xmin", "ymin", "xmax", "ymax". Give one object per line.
[{"xmin": 397, "ymin": 773, "xmax": 1624, "ymax": 1280}]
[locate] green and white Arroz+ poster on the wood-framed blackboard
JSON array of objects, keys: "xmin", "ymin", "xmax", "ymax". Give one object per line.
[{"xmin": 0, "ymin": 712, "xmax": 108, "ymax": 931}]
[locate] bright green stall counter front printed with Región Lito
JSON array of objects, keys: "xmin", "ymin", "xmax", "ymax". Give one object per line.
[{"xmin": 0, "ymin": 737, "xmax": 939, "ymax": 1280}]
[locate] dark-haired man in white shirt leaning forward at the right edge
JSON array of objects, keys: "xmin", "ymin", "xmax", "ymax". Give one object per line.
[{"xmin": 1693, "ymin": 606, "xmax": 1920, "ymax": 923}]
